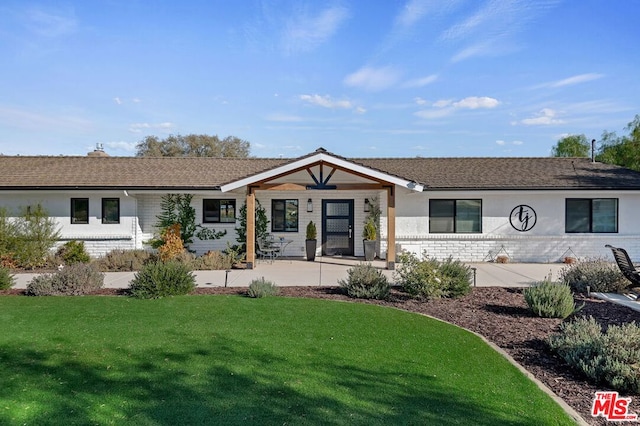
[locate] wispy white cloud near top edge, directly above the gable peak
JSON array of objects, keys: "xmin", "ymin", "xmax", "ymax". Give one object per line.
[{"xmin": 282, "ymin": 6, "xmax": 349, "ymax": 53}]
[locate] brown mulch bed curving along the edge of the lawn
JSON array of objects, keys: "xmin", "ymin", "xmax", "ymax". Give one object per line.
[{"xmin": 0, "ymin": 287, "xmax": 640, "ymax": 425}]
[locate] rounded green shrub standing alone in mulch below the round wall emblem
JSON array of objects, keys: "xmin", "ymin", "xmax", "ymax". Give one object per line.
[{"xmin": 524, "ymin": 281, "xmax": 579, "ymax": 318}]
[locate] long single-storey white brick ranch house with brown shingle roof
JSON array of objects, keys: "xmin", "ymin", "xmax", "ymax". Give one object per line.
[{"xmin": 0, "ymin": 148, "xmax": 640, "ymax": 269}]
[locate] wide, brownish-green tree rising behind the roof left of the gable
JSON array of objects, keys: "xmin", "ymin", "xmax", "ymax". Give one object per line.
[{"xmin": 136, "ymin": 134, "xmax": 251, "ymax": 158}]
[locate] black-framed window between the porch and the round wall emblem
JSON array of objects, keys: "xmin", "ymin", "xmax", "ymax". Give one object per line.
[{"xmin": 429, "ymin": 200, "xmax": 482, "ymax": 234}]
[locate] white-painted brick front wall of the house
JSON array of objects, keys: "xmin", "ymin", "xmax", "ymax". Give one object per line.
[{"xmin": 5, "ymin": 189, "xmax": 640, "ymax": 262}]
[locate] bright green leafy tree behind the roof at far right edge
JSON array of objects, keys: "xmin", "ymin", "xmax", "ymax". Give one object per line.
[{"xmin": 596, "ymin": 115, "xmax": 640, "ymax": 171}]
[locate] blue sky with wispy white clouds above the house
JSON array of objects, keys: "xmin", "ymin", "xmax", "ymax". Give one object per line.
[{"xmin": 0, "ymin": 0, "xmax": 640, "ymax": 157}]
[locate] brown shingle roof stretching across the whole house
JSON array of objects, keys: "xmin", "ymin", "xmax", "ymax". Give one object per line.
[{"xmin": 0, "ymin": 153, "xmax": 640, "ymax": 190}]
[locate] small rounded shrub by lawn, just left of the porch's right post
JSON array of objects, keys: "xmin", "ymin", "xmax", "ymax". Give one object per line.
[{"xmin": 338, "ymin": 263, "xmax": 391, "ymax": 300}]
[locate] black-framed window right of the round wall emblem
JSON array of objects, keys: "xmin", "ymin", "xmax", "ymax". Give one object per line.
[{"xmin": 564, "ymin": 198, "xmax": 618, "ymax": 233}]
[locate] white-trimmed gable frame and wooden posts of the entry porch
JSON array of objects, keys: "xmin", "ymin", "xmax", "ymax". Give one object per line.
[{"xmin": 220, "ymin": 148, "xmax": 424, "ymax": 270}]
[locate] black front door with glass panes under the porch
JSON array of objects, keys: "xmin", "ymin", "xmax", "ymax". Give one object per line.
[{"xmin": 322, "ymin": 200, "xmax": 353, "ymax": 256}]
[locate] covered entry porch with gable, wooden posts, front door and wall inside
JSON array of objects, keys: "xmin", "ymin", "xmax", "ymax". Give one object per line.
[{"xmin": 221, "ymin": 149, "xmax": 422, "ymax": 270}]
